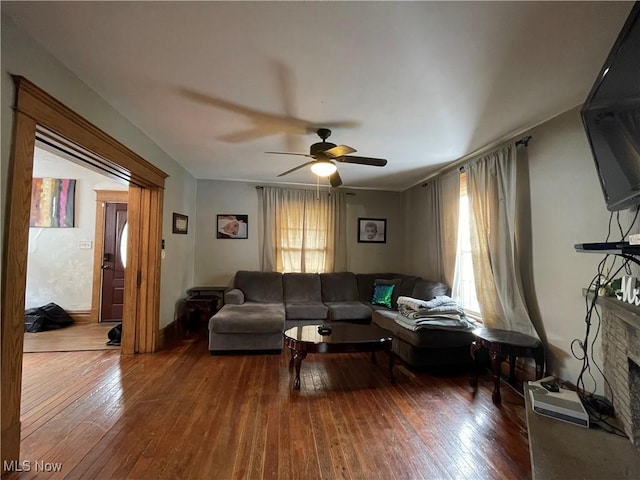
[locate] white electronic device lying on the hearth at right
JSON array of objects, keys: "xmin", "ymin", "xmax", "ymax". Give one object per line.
[{"xmin": 528, "ymin": 377, "xmax": 589, "ymax": 428}]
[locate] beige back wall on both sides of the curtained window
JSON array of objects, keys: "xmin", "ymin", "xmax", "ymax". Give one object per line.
[{"xmin": 194, "ymin": 180, "xmax": 403, "ymax": 285}]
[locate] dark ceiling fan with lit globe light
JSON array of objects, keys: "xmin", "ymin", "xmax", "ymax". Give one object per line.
[{"xmin": 265, "ymin": 128, "xmax": 387, "ymax": 187}]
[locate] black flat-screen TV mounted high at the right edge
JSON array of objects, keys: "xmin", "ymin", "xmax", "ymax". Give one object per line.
[{"xmin": 581, "ymin": 2, "xmax": 640, "ymax": 211}]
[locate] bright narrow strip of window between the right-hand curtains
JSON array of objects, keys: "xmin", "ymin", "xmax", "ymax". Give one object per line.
[{"xmin": 452, "ymin": 172, "xmax": 481, "ymax": 320}]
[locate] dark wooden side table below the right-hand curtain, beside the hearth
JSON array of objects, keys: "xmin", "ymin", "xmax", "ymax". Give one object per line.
[{"xmin": 470, "ymin": 328, "xmax": 544, "ymax": 403}]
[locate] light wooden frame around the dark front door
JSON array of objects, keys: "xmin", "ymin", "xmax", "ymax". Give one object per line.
[{"xmin": 89, "ymin": 190, "xmax": 129, "ymax": 323}]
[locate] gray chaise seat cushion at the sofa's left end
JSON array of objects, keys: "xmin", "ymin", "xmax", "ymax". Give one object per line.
[{"xmin": 209, "ymin": 302, "xmax": 285, "ymax": 333}]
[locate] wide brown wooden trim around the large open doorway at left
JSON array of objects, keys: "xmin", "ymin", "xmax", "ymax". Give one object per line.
[{"xmin": 0, "ymin": 76, "xmax": 167, "ymax": 470}]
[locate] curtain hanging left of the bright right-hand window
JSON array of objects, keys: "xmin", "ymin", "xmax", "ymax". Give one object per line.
[{"xmin": 424, "ymin": 171, "xmax": 460, "ymax": 287}]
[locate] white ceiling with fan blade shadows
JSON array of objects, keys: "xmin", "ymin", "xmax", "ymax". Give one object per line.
[{"xmin": 2, "ymin": 1, "xmax": 633, "ymax": 191}]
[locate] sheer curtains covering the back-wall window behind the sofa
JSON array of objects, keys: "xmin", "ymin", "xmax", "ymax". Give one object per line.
[{"xmin": 261, "ymin": 187, "xmax": 346, "ymax": 273}]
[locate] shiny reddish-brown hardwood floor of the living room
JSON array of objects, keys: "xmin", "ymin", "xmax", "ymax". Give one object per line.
[{"xmin": 6, "ymin": 337, "xmax": 531, "ymax": 480}]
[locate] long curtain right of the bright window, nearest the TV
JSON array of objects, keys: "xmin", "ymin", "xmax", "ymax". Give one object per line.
[{"xmin": 465, "ymin": 143, "xmax": 538, "ymax": 337}]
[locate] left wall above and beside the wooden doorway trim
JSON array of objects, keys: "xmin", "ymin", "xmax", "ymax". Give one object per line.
[{"xmin": 0, "ymin": 15, "xmax": 195, "ymax": 327}]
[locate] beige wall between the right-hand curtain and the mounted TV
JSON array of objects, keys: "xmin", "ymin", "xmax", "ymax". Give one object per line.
[{"xmin": 528, "ymin": 108, "xmax": 628, "ymax": 391}]
